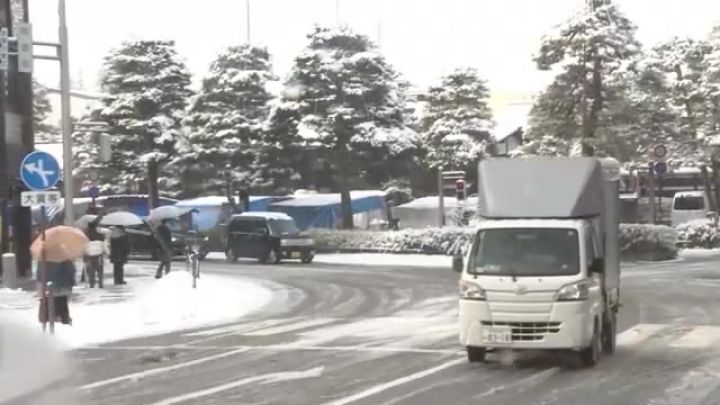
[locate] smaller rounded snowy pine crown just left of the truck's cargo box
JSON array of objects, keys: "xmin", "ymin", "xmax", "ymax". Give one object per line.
[{"xmin": 422, "ymin": 69, "xmax": 493, "ymax": 170}]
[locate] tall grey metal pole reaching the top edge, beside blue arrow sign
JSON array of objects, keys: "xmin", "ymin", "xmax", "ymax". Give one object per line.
[{"xmin": 58, "ymin": 0, "xmax": 75, "ymax": 225}]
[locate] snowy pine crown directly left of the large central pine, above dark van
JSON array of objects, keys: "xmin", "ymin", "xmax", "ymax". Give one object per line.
[{"xmin": 174, "ymin": 45, "xmax": 274, "ymax": 196}]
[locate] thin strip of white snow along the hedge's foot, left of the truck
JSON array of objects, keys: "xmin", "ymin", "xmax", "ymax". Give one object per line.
[{"xmin": 315, "ymin": 253, "xmax": 452, "ymax": 269}]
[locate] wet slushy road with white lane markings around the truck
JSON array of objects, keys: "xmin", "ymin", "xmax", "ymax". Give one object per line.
[{"xmin": 5, "ymin": 253, "xmax": 720, "ymax": 405}]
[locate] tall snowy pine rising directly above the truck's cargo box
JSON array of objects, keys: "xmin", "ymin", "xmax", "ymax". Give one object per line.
[{"xmin": 528, "ymin": 0, "xmax": 640, "ymax": 154}]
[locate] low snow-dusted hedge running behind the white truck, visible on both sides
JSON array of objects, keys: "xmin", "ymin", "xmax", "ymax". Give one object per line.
[{"xmin": 311, "ymin": 224, "xmax": 677, "ymax": 261}]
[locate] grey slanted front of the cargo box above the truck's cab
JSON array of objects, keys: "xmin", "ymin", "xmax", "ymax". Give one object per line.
[{"xmin": 478, "ymin": 158, "xmax": 604, "ymax": 218}]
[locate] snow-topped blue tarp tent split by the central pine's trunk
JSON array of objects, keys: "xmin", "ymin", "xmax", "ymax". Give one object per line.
[{"xmin": 270, "ymin": 191, "xmax": 387, "ymax": 230}]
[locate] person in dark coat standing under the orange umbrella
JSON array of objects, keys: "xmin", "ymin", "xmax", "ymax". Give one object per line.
[{"xmin": 35, "ymin": 260, "xmax": 77, "ymax": 325}]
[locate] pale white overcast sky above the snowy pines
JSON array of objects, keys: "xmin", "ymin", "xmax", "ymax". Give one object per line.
[{"xmin": 30, "ymin": 0, "xmax": 720, "ymax": 117}]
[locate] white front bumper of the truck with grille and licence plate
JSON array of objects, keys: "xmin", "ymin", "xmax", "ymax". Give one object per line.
[{"xmin": 460, "ymin": 300, "xmax": 594, "ymax": 350}]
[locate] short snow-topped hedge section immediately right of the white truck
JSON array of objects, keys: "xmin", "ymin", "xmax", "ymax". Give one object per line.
[{"xmin": 620, "ymin": 224, "xmax": 678, "ymax": 261}]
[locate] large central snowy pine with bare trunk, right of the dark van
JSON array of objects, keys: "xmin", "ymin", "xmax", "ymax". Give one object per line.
[{"xmin": 289, "ymin": 27, "xmax": 417, "ymax": 228}]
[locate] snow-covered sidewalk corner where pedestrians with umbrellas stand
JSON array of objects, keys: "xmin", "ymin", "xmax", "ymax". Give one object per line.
[{"xmin": 0, "ymin": 266, "xmax": 272, "ymax": 348}]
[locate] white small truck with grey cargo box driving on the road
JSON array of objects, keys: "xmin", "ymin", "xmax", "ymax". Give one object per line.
[{"xmin": 453, "ymin": 157, "xmax": 620, "ymax": 367}]
